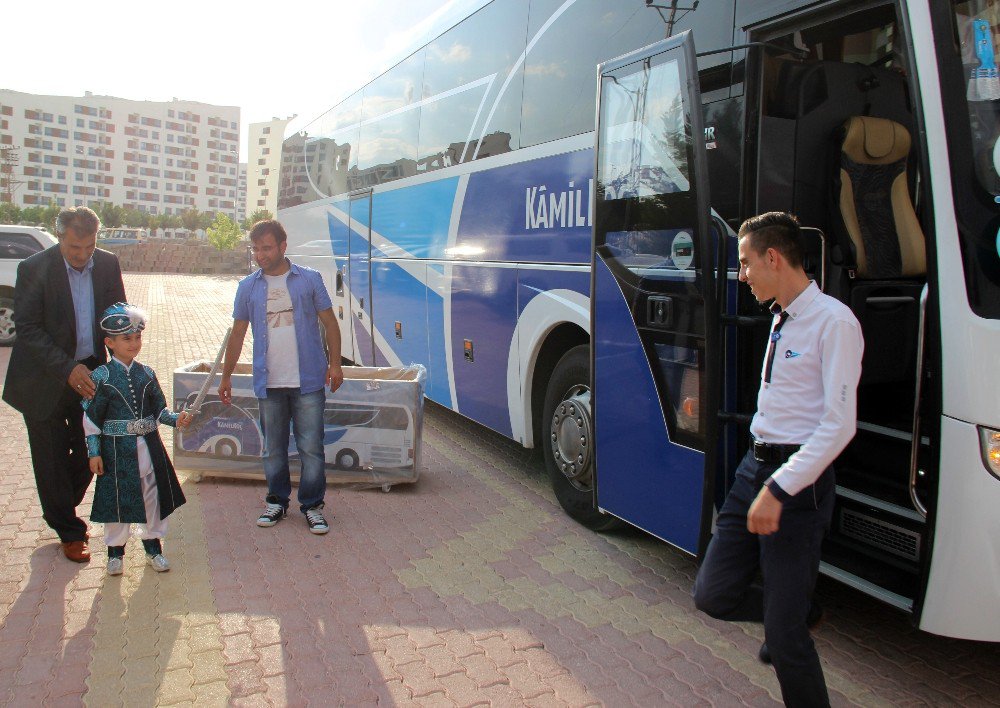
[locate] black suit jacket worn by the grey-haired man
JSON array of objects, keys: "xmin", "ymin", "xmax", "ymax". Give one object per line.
[{"xmin": 3, "ymin": 245, "xmax": 125, "ymax": 419}]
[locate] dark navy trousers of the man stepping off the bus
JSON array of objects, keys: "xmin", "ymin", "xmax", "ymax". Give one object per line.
[{"xmin": 694, "ymin": 453, "xmax": 835, "ymax": 707}]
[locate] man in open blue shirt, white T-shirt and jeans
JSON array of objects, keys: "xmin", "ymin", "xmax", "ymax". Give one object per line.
[{"xmin": 219, "ymin": 219, "xmax": 344, "ymax": 534}]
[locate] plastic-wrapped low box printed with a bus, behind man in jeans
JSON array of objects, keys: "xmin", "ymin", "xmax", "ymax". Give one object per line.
[{"xmin": 174, "ymin": 361, "xmax": 427, "ymax": 490}]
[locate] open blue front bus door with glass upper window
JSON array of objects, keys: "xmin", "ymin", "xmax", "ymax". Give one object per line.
[{"xmin": 591, "ymin": 32, "xmax": 719, "ymax": 553}]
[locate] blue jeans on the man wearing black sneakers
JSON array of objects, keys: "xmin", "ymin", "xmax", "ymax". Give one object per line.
[{"xmin": 259, "ymin": 388, "xmax": 326, "ymax": 511}]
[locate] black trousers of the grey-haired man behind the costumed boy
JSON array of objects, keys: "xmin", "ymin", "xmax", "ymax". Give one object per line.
[{"xmin": 24, "ymin": 387, "xmax": 94, "ymax": 543}]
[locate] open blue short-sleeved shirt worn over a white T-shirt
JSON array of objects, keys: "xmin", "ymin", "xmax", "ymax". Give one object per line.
[{"xmin": 233, "ymin": 262, "xmax": 333, "ymax": 398}]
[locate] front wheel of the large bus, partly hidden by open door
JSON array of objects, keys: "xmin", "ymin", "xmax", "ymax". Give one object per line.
[{"xmin": 542, "ymin": 345, "xmax": 619, "ymax": 531}]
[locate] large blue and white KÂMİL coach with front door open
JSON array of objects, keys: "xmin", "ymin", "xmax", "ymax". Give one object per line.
[{"xmin": 278, "ymin": 0, "xmax": 1000, "ymax": 641}]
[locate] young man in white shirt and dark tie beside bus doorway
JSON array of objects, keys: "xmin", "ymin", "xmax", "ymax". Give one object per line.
[{"xmin": 694, "ymin": 212, "xmax": 864, "ymax": 706}]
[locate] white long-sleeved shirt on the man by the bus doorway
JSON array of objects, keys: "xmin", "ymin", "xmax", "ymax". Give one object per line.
[{"xmin": 750, "ymin": 282, "xmax": 864, "ymax": 496}]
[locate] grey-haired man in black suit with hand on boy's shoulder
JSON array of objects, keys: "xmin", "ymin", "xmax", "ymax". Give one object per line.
[{"xmin": 3, "ymin": 207, "xmax": 125, "ymax": 563}]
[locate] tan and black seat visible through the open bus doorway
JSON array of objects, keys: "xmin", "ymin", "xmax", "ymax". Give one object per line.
[{"xmin": 831, "ymin": 116, "xmax": 927, "ymax": 383}]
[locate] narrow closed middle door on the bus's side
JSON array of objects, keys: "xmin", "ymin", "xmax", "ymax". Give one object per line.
[{"xmin": 348, "ymin": 190, "xmax": 375, "ymax": 366}]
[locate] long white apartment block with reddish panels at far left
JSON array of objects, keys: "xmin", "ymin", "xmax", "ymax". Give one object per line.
[{"xmin": 0, "ymin": 89, "xmax": 241, "ymax": 218}]
